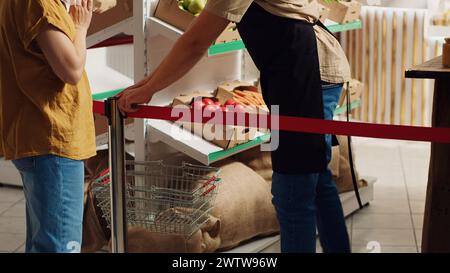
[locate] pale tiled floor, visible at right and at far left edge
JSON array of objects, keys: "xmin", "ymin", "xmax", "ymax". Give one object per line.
[{"xmin": 0, "ymin": 138, "xmax": 429, "ymax": 253}]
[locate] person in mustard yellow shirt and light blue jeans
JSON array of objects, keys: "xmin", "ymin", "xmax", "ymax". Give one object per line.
[{"xmin": 0, "ymin": 0, "xmax": 96, "ymax": 252}]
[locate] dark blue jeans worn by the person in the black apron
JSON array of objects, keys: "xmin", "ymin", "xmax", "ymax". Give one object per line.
[{"xmin": 272, "ymin": 85, "xmax": 350, "ymax": 253}]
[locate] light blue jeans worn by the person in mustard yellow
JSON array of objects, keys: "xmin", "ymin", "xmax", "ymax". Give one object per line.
[{"xmin": 13, "ymin": 155, "xmax": 84, "ymax": 253}]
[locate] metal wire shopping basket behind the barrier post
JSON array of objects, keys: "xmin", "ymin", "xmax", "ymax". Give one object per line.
[{"xmin": 93, "ymin": 161, "xmax": 221, "ymax": 236}]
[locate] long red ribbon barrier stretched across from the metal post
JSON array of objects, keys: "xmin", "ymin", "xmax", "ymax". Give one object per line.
[{"xmin": 90, "ymin": 101, "xmax": 450, "ymax": 143}]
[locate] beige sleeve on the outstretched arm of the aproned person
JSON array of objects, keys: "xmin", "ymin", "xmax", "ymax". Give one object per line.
[{"xmin": 205, "ymin": 0, "xmax": 253, "ymax": 23}]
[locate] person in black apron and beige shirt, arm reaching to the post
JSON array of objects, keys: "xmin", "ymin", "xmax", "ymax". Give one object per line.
[{"xmin": 119, "ymin": 0, "xmax": 350, "ymax": 253}]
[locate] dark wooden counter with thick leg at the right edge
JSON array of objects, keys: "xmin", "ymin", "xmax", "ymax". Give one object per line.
[{"xmin": 405, "ymin": 56, "xmax": 450, "ymax": 253}]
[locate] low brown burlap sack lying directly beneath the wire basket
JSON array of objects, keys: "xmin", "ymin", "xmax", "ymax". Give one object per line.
[{"xmin": 109, "ymin": 216, "xmax": 221, "ymax": 253}]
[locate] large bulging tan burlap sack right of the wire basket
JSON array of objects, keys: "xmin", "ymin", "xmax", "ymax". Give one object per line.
[{"xmin": 211, "ymin": 161, "xmax": 279, "ymax": 250}]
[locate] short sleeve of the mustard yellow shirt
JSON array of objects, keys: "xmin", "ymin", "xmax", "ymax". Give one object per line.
[{"xmin": 19, "ymin": 0, "xmax": 72, "ymax": 48}]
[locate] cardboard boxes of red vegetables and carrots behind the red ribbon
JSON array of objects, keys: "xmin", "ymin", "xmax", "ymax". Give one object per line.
[{"xmin": 172, "ymin": 82, "xmax": 269, "ymax": 149}]
